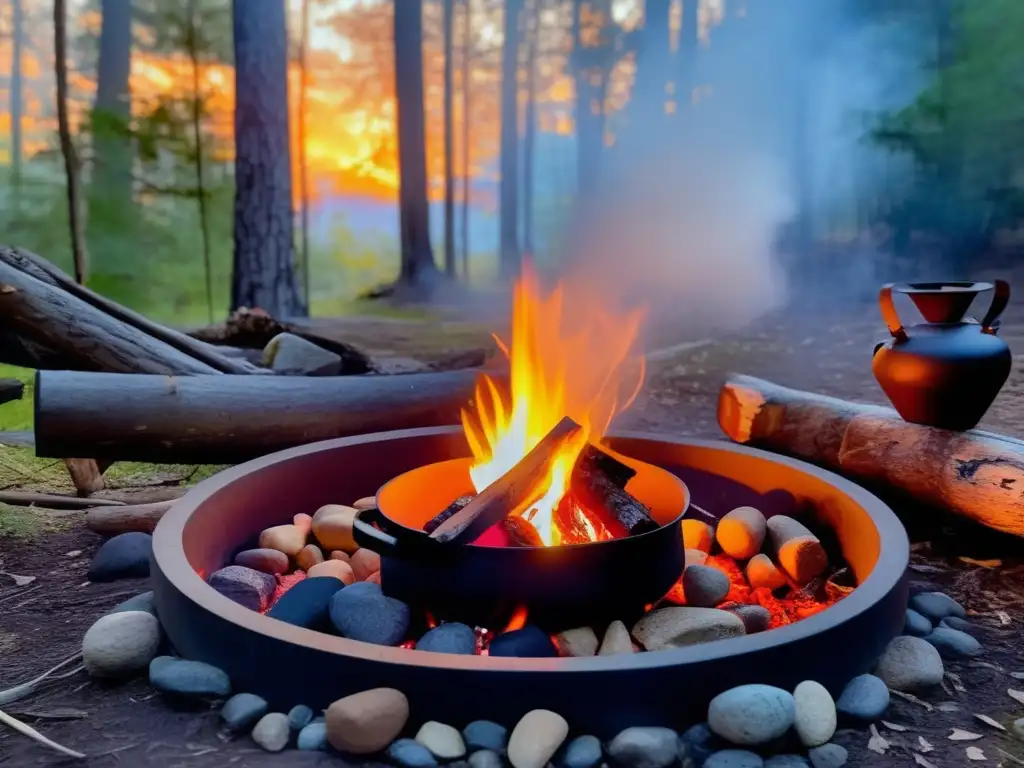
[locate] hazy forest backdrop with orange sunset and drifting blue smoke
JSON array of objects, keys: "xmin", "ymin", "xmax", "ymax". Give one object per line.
[{"xmin": 0, "ymin": 0, "xmax": 1024, "ymax": 325}]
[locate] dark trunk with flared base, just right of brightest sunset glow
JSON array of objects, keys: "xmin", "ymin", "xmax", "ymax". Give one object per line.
[{"xmin": 394, "ymin": 0, "xmax": 437, "ymax": 288}]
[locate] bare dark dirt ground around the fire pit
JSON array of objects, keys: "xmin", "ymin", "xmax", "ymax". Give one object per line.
[{"xmin": 0, "ymin": 306, "xmax": 1024, "ymax": 768}]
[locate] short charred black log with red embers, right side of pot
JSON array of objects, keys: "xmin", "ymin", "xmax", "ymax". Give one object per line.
[{"xmin": 569, "ymin": 446, "xmax": 658, "ymax": 539}]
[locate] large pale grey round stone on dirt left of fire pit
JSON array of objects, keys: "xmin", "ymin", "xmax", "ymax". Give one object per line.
[{"xmin": 82, "ymin": 610, "xmax": 161, "ymax": 678}]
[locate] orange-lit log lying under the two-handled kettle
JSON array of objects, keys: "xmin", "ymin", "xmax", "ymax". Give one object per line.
[{"xmin": 718, "ymin": 376, "xmax": 1024, "ymax": 536}]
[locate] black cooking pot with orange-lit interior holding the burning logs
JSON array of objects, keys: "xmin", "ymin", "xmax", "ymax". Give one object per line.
[{"xmin": 354, "ymin": 456, "xmax": 689, "ymax": 632}]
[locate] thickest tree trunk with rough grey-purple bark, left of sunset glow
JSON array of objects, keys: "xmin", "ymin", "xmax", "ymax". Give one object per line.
[{"xmin": 231, "ymin": 0, "xmax": 307, "ymax": 318}]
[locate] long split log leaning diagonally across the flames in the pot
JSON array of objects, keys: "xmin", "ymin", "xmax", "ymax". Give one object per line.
[{"xmin": 430, "ymin": 417, "xmax": 581, "ymax": 544}]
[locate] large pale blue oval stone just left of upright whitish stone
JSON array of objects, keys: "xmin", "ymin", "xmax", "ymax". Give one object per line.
[{"xmin": 708, "ymin": 684, "xmax": 797, "ymax": 746}]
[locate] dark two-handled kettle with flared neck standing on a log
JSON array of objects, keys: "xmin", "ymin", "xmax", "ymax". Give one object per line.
[{"xmin": 871, "ymin": 280, "xmax": 1013, "ymax": 430}]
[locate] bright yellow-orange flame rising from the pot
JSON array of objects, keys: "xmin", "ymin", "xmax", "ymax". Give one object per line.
[{"xmin": 462, "ymin": 263, "xmax": 644, "ymax": 546}]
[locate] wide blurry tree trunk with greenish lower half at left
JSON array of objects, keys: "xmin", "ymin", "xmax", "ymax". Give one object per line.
[{"xmin": 90, "ymin": 0, "xmax": 132, "ymax": 210}]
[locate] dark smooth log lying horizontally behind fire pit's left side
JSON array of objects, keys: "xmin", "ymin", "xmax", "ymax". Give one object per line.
[{"xmin": 35, "ymin": 369, "xmax": 491, "ymax": 464}]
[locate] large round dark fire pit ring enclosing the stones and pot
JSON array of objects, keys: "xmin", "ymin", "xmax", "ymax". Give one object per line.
[{"xmin": 153, "ymin": 428, "xmax": 908, "ymax": 735}]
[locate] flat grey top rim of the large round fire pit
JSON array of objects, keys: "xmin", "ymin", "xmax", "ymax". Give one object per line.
[{"xmin": 153, "ymin": 427, "xmax": 909, "ymax": 673}]
